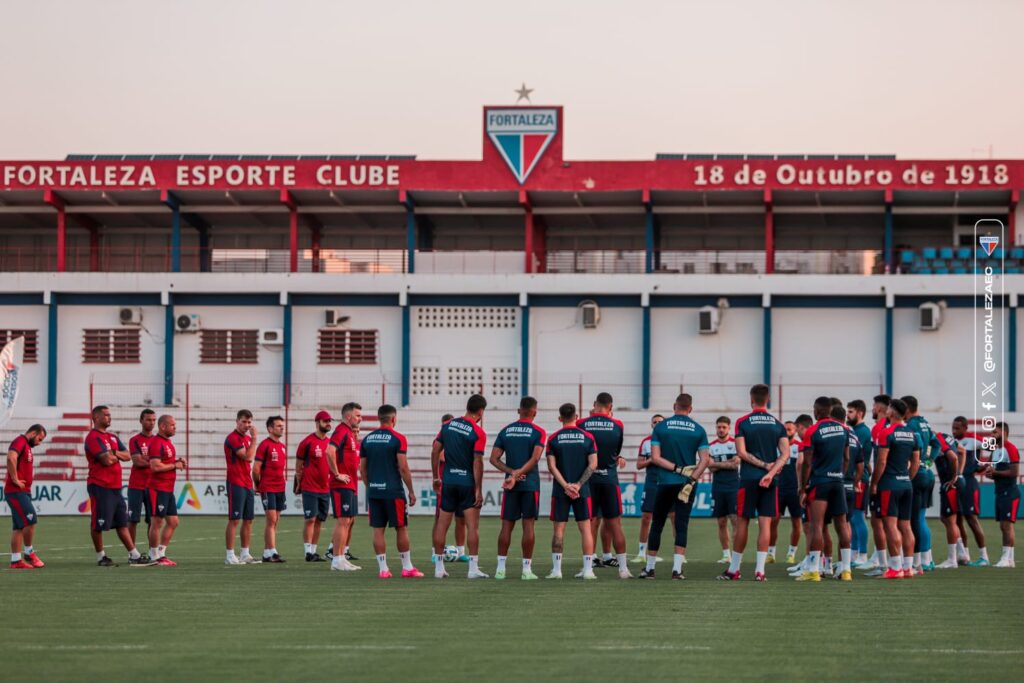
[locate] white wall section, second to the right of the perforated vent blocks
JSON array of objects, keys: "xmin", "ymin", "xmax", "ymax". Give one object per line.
[{"xmin": 650, "ymin": 307, "xmax": 763, "ymax": 411}]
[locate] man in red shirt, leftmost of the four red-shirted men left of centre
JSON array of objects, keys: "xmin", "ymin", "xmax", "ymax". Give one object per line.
[{"xmin": 224, "ymin": 409, "xmax": 259, "ymax": 564}]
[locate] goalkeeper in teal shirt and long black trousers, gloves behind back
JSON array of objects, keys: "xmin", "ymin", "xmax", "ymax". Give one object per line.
[{"xmin": 640, "ymin": 393, "xmax": 711, "ymax": 581}]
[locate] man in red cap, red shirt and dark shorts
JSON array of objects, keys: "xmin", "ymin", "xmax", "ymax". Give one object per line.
[{"xmin": 295, "ymin": 411, "xmax": 332, "ymax": 562}]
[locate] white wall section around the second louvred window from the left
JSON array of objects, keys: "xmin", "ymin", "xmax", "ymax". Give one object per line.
[{"xmin": 57, "ymin": 305, "xmax": 164, "ymax": 408}]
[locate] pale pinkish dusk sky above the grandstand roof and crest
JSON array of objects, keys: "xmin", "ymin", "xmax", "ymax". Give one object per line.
[{"xmin": 0, "ymin": 0, "xmax": 1024, "ymax": 160}]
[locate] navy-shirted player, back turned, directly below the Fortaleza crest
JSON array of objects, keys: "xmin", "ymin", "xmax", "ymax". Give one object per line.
[{"xmin": 490, "ymin": 396, "xmax": 547, "ymax": 581}]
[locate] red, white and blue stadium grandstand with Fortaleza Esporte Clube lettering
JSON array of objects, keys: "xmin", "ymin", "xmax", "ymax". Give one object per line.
[{"xmin": 0, "ymin": 106, "xmax": 1024, "ymax": 507}]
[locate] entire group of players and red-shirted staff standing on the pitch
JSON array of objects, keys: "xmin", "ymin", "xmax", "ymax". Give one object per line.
[{"xmin": 4, "ymin": 384, "xmax": 1020, "ymax": 582}]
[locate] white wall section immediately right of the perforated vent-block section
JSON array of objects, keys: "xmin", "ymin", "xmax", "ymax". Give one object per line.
[{"xmin": 529, "ymin": 306, "xmax": 643, "ymax": 414}]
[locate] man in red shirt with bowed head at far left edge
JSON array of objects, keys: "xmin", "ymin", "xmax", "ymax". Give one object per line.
[{"xmin": 3, "ymin": 425, "xmax": 46, "ymax": 569}]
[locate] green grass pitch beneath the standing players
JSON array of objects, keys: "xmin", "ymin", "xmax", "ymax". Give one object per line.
[{"xmin": 0, "ymin": 517, "xmax": 1024, "ymax": 683}]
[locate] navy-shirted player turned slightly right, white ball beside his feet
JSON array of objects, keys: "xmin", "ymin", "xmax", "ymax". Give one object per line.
[{"xmin": 430, "ymin": 394, "xmax": 489, "ymax": 579}]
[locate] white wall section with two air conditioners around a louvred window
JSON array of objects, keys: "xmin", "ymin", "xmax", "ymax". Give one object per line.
[{"xmin": 174, "ymin": 305, "xmax": 284, "ymax": 408}]
